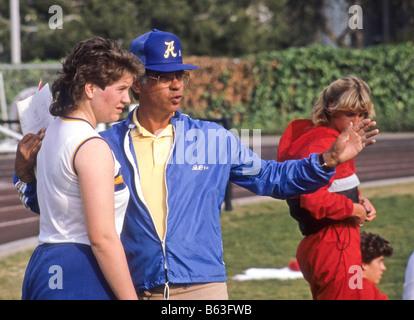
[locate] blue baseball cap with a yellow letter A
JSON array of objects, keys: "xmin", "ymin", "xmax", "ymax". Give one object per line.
[{"xmin": 129, "ymin": 29, "xmax": 198, "ymax": 72}]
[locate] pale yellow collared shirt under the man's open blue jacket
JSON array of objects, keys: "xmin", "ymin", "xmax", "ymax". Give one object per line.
[{"xmin": 131, "ymin": 112, "xmax": 174, "ymax": 239}]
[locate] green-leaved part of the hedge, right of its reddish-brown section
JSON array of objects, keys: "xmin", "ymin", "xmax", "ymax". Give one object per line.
[{"xmin": 242, "ymin": 43, "xmax": 414, "ymax": 132}]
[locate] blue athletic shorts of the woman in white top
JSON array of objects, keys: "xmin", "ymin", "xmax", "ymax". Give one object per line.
[{"xmin": 22, "ymin": 243, "xmax": 115, "ymax": 300}]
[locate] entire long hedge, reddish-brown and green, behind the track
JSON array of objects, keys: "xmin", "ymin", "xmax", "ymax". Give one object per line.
[{"xmin": 0, "ymin": 43, "xmax": 414, "ymax": 134}]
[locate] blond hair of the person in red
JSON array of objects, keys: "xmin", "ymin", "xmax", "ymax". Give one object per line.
[{"xmin": 312, "ymin": 76, "xmax": 375, "ymax": 127}]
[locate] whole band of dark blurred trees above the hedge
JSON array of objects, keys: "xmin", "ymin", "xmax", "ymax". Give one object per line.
[{"xmin": 0, "ymin": 0, "xmax": 414, "ymax": 62}]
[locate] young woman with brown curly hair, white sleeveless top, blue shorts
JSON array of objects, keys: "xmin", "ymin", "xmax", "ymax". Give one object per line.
[{"xmin": 22, "ymin": 38, "xmax": 144, "ymax": 300}]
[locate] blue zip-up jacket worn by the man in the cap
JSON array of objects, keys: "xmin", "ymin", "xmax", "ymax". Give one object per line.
[{"xmin": 15, "ymin": 110, "xmax": 335, "ymax": 290}]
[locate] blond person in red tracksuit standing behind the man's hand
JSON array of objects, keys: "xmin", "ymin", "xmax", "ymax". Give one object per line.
[{"xmin": 277, "ymin": 76, "xmax": 376, "ymax": 300}]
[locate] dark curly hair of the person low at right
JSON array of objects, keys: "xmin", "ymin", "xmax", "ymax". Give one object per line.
[{"xmin": 361, "ymin": 231, "xmax": 394, "ymax": 264}]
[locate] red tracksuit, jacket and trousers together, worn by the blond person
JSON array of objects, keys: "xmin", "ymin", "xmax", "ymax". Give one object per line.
[{"xmin": 278, "ymin": 120, "xmax": 365, "ymax": 300}]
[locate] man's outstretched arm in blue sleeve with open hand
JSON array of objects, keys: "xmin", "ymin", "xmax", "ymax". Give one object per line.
[{"xmin": 230, "ymin": 119, "xmax": 379, "ymax": 199}]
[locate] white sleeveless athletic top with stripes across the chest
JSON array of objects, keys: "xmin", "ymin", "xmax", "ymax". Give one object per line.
[{"xmin": 36, "ymin": 117, "xmax": 129, "ymax": 245}]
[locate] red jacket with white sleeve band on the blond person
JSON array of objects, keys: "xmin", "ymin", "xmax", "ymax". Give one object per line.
[{"xmin": 277, "ymin": 119, "xmax": 359, "ymax": 235}]
